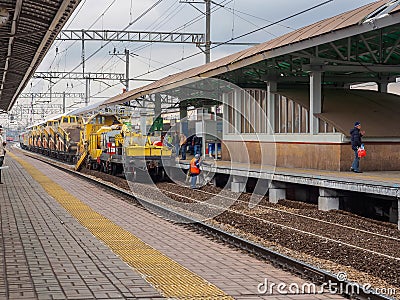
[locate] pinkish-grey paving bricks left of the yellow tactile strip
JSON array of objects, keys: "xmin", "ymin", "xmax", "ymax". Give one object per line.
[{"xmin": 0, "ymin": 157, "xmax": 163, "ymax": 300}]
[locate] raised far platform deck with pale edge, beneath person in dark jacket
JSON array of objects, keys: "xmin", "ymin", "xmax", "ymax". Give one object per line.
[{"xmin": 176, "ymin": 156, "xmax": 400, "ymax": 198}]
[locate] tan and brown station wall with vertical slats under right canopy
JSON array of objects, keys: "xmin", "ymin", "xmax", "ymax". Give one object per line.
[{"xmin": 222, "ymin": 90, "xmax": 400, "ymax": 171}]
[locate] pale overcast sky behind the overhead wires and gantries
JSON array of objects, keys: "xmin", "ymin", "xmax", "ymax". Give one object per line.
[{"xmin": 19, "ymin": 0, "xmax": 374, "ymax": 115}]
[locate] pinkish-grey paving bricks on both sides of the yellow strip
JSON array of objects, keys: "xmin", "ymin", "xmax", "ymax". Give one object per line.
[{"xmin": 0, "ymin": 152, "xmax": 343, "ymax": 300}]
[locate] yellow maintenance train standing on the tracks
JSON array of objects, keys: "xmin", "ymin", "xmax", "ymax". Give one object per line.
[{"xmin": 20, "ymin": 113, "xmax": 172, "ymax": 181}]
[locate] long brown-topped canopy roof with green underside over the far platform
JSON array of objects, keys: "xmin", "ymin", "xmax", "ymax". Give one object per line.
[{"xmin": 102, "ymin": 0, "xmax": 400, "ymax": 106}]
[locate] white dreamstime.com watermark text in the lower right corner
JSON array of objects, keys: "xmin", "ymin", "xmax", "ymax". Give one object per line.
[{"xmin": 257, "ymin": 272, "xmax": 397, "ymax": 296}]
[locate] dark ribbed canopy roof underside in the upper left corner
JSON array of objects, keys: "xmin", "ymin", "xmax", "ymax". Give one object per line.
[{"xmin": 0, "ymin": 0, "xmax": 80, "ymax": 112}]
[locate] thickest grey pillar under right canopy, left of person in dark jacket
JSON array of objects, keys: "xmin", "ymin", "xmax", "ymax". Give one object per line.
[{"xmin": 310, "ymin": 71, "xmax": 322, "ymax": 134}]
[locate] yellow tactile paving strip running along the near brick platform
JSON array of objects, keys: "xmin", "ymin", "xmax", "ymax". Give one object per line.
[{"xmin": 10, "ymin": 153, "xmax": 233, "ymax": 299}]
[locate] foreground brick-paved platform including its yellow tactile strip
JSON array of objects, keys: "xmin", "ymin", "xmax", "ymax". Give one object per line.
[{"xmin": 0, "ymin": 151, "xmax": 343, "ymax": 300}]
